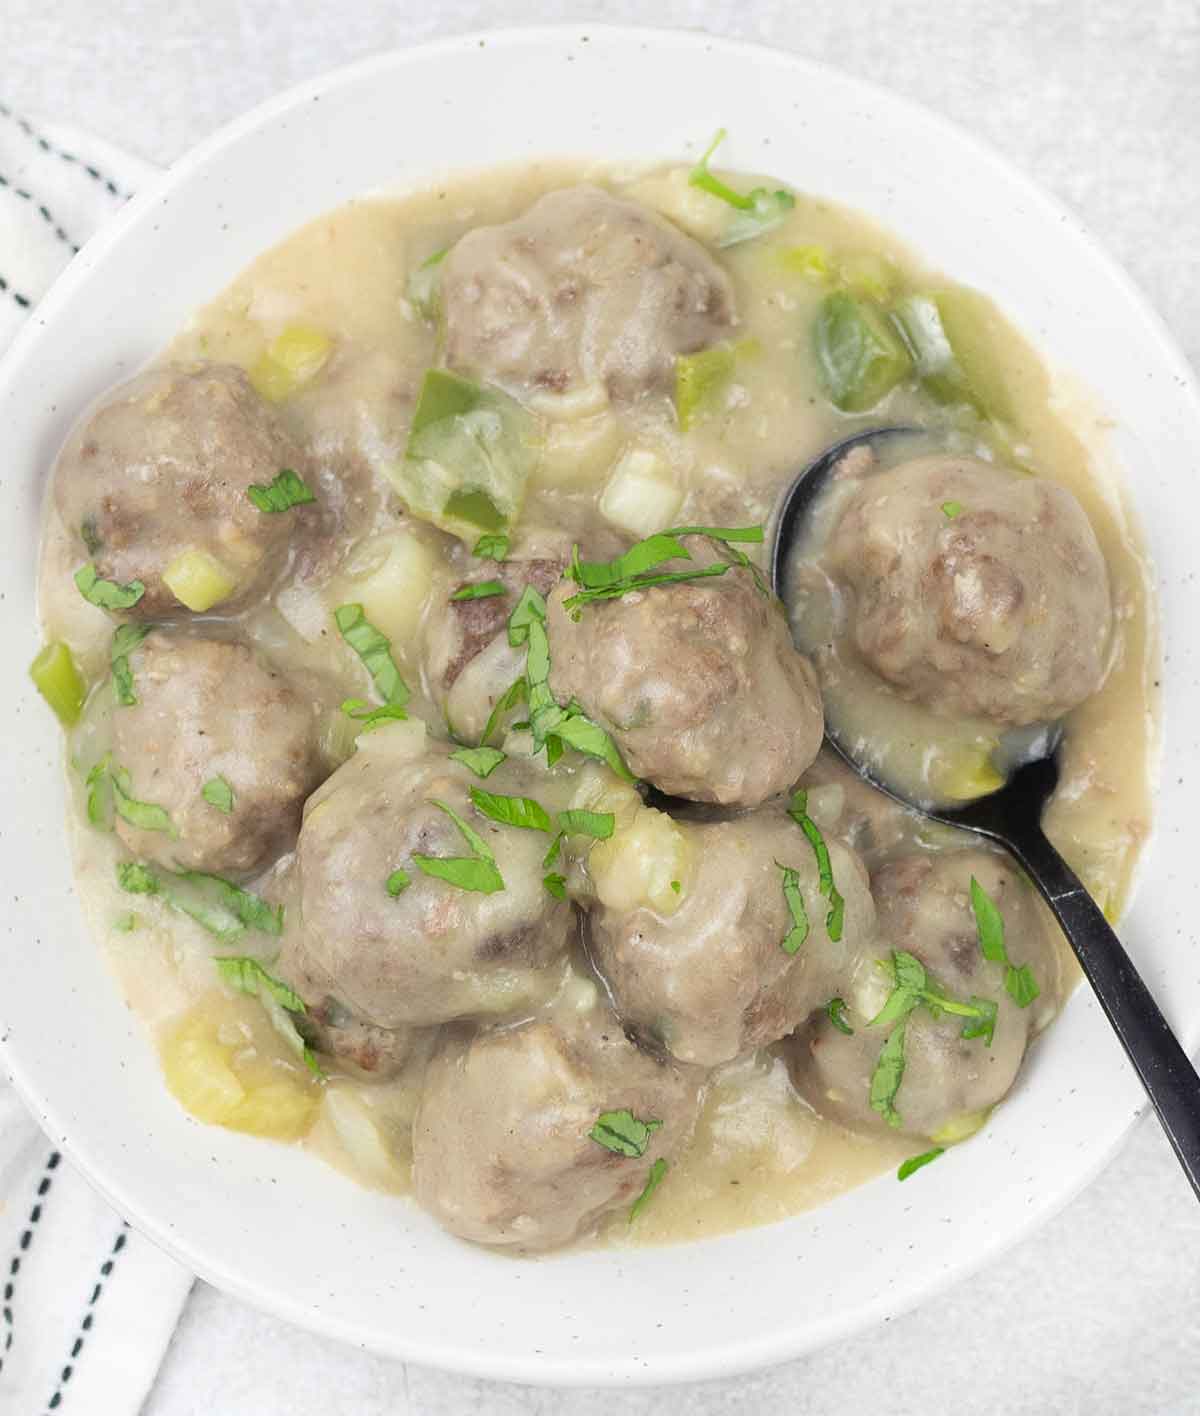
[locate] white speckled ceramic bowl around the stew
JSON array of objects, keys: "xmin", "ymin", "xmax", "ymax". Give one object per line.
[{"xmin": 0, "ymin": 27, "xmax": 1200, "ymax": 1383}]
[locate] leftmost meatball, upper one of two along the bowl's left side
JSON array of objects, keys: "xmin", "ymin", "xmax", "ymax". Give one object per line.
[{"xmin": 54, "ymin": 364, "xmax": 313, "ymax": 619}]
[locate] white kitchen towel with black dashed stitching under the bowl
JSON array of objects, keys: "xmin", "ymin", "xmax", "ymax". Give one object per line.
[{"xmin": 0, "ymin": 102, "xmax": 191, "ymax": 1416}]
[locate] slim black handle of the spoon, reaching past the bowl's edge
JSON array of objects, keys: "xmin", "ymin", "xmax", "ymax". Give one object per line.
[{"xmin": 1006, "ymin": 824, "xmax": 1200, "ymax": 1198}]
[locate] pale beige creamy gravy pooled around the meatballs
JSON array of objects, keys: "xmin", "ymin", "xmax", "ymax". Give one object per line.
[{"xmin": 41, "ymin": 163, "xmax": 1157, "ymax": 1242}]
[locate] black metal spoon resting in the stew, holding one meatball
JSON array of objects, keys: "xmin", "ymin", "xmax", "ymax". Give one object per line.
[{"xmin": 771, "ymin": 428, "xmax": 1200, "ymax": 1198}]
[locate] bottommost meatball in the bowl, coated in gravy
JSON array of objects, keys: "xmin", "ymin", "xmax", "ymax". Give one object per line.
[{"xmin": 412, "ymin": 1010, "xmax": 704, "ymax": 1250}]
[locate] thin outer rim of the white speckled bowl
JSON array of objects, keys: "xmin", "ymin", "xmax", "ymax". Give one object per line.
[{"xmin": 0, "ymin": 23, "xmax": 1200, "ymax": 1386}]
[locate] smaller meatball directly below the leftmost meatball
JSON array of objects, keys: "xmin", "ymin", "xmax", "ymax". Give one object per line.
[{"xmin": 112, "ymin": 630, "xmax": 327, "ymax": 875}]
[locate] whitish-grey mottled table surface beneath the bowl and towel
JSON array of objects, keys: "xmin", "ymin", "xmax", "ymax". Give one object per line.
[{"xmin": 0, "ymin": 0, "xmax": 1200, "ymax": 1416}]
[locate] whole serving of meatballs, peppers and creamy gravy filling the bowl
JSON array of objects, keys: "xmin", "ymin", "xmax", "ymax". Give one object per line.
[{"xmin": 33, "ymin": 150, "xmax": 1155, "ymax": 1253}]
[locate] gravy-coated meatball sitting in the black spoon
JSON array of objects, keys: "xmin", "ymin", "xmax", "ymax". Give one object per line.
[{"xmin": 825, "ymin": 456, "xmax": 1112, "ymax": 726}]
